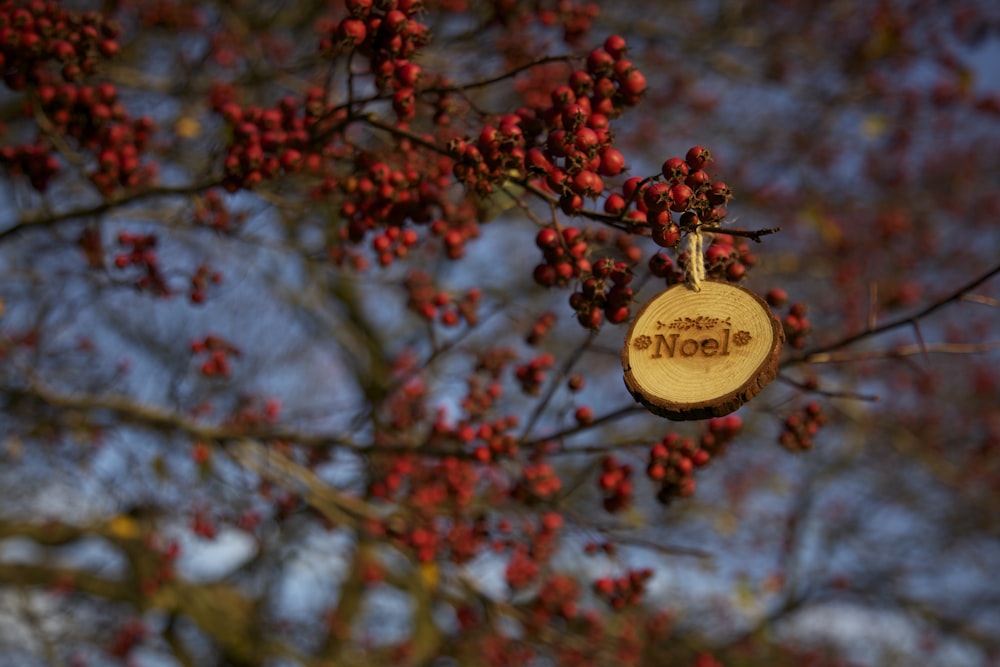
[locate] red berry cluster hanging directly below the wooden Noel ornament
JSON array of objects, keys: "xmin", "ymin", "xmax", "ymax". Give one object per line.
[{"xmin": 646, "ymin": 415, "xmax": 743, "ymax": 503}]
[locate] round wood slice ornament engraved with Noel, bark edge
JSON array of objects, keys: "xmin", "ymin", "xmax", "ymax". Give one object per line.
[{"xmin": 622, "ymin": 281, "xmax": 784, "ymax": 420}]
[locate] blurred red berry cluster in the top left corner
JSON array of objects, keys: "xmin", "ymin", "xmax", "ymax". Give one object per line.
[{"xmin": 0, "ymin": 0, "xmax": 120, "ymax": 90}]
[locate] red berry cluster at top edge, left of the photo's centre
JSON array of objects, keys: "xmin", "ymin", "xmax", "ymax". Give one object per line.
[{"xmin": 320, "ymin": 0, "xmax": 430, "ymax": 95}]
